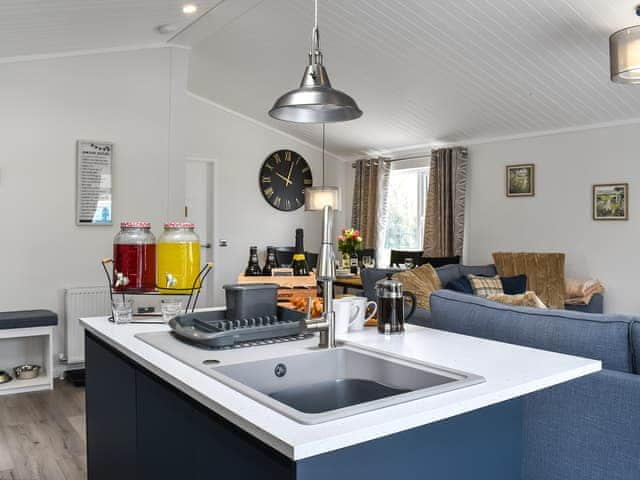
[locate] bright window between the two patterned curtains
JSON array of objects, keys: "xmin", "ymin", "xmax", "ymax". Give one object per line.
[{"xmin": 384, "ymin": 167, "xmax": 429, "ymax": 251}]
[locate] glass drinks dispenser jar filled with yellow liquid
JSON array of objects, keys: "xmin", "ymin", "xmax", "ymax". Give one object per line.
[{"xmin": 157, "ymin": 222, "xmax": 200, "ymax": 292}]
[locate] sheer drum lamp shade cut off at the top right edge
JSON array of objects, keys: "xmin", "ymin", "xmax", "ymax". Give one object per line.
[{"xmin": 609, "ymin": 25, "xmax": 640, "ymax": 84}]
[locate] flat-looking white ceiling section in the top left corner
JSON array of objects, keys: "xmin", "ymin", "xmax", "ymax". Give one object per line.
[{"xmin": 0, "ymin": 0, "xmax": 220, "ymax": 58}]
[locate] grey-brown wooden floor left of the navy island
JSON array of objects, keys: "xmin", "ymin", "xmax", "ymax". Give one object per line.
[{"xmin": 0, "ymin": 381, "xmax": 87, "ymax": 480}]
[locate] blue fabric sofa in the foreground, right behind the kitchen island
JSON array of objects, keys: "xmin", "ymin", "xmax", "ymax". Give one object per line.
[{"xmin": 430, "ymin": 290, "xmax": 640, "ymax": 480}]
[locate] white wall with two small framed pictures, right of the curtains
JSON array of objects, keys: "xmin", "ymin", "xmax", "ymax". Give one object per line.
[{"xmin": 465, "ymin": 125, "xmax": 640, "ymax": 313}]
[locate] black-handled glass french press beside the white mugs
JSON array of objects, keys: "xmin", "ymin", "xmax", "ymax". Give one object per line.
[{"xmin": 376, "ymin": 274, "xmax": 416, "ymax": 333}]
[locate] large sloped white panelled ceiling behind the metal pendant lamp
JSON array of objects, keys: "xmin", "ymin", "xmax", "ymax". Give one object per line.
[{"xmin": 188, "ymin": 0, "xmax": 640, "ymax": 158}]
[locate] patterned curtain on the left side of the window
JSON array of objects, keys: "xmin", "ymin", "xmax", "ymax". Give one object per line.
[{"xmin": 351, "ymin": 158, "xmax": 391, "ymax": 258}]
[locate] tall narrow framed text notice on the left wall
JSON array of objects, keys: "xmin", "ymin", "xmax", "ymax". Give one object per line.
[{"xmin": 76, "ymin": 140, "xmax": 113, "ymax": 225}]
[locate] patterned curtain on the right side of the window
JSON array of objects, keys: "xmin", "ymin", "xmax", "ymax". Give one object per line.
[{"xmin": 424, "ymin": 147, "xmax": 467, "ymax": 257}]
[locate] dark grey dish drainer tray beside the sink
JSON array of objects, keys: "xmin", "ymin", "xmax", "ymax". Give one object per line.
[{"xmin": 169, "ymin": 307, "xmax": 305, "ymax": 348}]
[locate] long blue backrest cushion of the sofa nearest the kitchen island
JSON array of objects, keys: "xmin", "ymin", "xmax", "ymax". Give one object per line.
[{"xmin": 431, "ymin": 290, "xmax": 640, "ymax": 372}]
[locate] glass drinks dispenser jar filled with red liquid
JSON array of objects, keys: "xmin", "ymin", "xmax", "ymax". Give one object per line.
[{"xmin": 113, "ymin": 222, "xmax": 156, "ymax": 292}]
